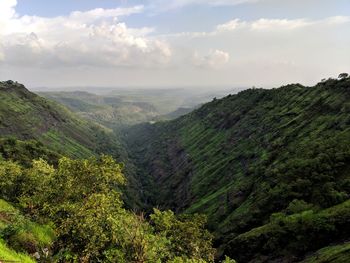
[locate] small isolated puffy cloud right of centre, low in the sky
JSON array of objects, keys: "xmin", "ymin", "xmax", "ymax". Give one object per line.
[{"xmin": 192, "ymin": 49, "xmax": 230, "ymax": 69}]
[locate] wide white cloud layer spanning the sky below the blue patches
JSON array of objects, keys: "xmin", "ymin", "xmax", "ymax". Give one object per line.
[{"xmin": 0, "ymin": 0, "xmax": 350, "ymax": 86}]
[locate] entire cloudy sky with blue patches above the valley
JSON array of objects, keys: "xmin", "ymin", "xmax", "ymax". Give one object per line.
[{"xmin": 0, "ymin": 0, "xmax": 350, "ymax": 89}]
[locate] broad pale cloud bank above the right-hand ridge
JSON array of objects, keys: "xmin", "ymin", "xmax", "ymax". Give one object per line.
[{"xmin": 165, "ymin": 16, "xmax": 350, "ymax": 86}]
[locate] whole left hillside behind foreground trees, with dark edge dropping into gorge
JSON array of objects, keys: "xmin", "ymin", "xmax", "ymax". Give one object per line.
[{"xmin": 0, "ymin": 81, "xmax": 140, "ymax": 207}]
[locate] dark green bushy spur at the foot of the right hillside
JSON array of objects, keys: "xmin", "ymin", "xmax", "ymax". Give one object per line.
[{"xmin": 228, "ymin": 201, "xmax": 350, "ymax": 262}]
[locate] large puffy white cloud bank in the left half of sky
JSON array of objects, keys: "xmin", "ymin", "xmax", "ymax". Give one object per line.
[{"xmin": 0, "ymin": 0, "xmax": 172, "ymax": 68}]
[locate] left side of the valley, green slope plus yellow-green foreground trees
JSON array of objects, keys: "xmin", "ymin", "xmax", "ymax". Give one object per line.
[{"xmin": 0, "ymin": 81, "xmax": 234, "ymax": 263}]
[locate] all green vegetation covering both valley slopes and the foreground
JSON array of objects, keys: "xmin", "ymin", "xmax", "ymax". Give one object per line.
[{"xmin": 0, "ymin": 75, "xmax": 350, "ymax": 263}]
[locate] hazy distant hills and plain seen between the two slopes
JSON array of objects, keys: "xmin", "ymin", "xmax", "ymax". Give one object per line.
[{"xmin": 39, "ymin": 88, "xmax": 241, "ymax": 130}]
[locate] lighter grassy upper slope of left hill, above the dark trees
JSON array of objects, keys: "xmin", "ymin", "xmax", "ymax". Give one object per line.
[{"xmin": 0, "ymin": 81, "xmax": 125, "ymax": 158}]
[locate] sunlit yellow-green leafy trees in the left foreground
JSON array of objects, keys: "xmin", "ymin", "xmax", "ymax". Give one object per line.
[{"xmin": 0, "ymin": 156, "xmax": 219, "ymax": 263}]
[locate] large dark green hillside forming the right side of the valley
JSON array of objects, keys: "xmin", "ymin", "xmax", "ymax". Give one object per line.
[{"xmin": 126, "ymin": 77, "xmax": 350, "ymax": 262}]
